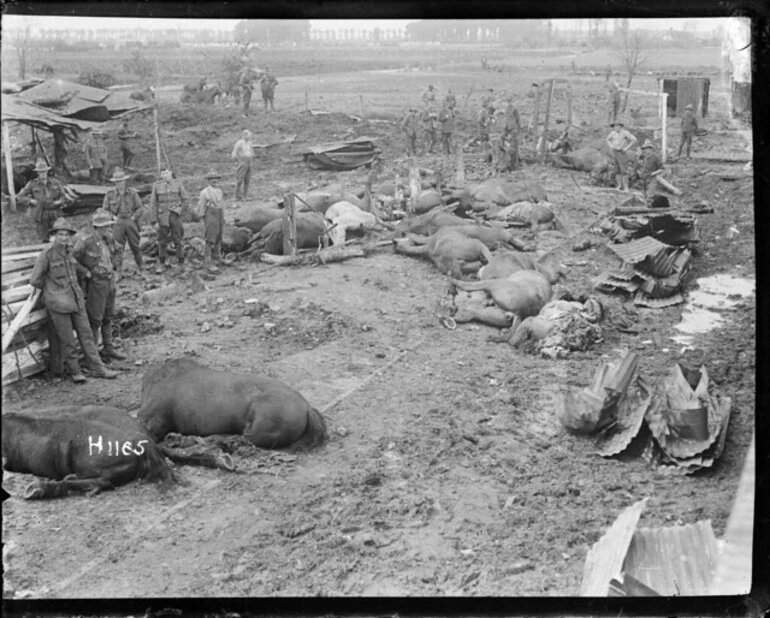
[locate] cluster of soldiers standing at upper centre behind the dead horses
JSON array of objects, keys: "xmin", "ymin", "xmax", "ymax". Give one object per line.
[{"xmin": 401, "ymin": 84, "xmax": 521, "ymax": 172}]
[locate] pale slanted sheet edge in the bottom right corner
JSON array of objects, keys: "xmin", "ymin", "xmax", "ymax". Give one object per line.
[{"xmin": 709, "ymin": 436, "xmax": 756, "ymax": 596}]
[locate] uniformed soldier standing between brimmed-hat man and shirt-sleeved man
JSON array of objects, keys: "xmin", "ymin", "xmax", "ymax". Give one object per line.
[{"xmin": 150, "ymin": 169, "xmax": 188, "ymax": 275}]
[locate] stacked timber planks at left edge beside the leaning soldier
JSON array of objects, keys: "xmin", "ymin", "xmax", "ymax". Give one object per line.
[{"xmin": 2, "ymin": 245, "xmax": 48, "ymax": 386}]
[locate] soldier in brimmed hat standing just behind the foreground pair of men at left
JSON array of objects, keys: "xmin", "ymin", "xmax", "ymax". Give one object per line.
[{"xmin": 102, "ymin": 167, "xmax": 144, "ymax": 281}]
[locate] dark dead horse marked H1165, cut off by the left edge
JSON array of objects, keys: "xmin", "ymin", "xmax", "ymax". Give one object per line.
[{"xmin": 2, "ymin": 405, "xmax": 177, "ymax": 499}]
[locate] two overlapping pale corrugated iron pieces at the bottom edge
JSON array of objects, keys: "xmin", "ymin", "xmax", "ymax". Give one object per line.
[{"xmin": 580, "ymin": 498, "xmax": 719, "ymax": 597}]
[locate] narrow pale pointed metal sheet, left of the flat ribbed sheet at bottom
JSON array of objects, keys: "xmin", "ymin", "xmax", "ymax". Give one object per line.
[{"xmin": 580, "ymin": 498, "xmax": 649, "ymax": 597}]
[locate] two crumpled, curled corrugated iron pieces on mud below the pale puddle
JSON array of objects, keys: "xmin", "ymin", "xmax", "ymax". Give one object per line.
[{"xmin": 558, "ymin": 352, "xmax": 731, "ymax": 474}]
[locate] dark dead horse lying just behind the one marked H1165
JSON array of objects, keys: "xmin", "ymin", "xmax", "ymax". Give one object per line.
[{"xmin": 138, "ymin": 358, "xmax": 327, "ymax": 448}]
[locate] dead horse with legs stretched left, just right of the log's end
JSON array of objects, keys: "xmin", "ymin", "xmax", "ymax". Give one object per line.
[{"xmin": 394, "ymin": 227, "xmax": 492, "ymax": 277}]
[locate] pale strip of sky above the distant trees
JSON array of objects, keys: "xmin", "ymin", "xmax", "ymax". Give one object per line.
[{"xmin": 3, "ymin": 15, "xmax": 726, "ymax": 32}]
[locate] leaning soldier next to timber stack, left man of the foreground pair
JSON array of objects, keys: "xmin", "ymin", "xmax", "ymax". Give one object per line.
[{"xmin": 29, "ymin": 218, "xmax": 117, "ymax": 382}]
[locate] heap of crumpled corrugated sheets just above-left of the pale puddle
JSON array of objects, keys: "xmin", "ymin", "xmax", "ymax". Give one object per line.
[{"xmin": 594, "ymin": 236, "xmax": 692, "ymax": 308}]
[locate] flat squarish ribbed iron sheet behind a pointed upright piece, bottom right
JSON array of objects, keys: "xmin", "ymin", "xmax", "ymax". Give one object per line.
[{"xmin": 623, "ymin": 520, "xmax": 718, "ymax": 596}]
